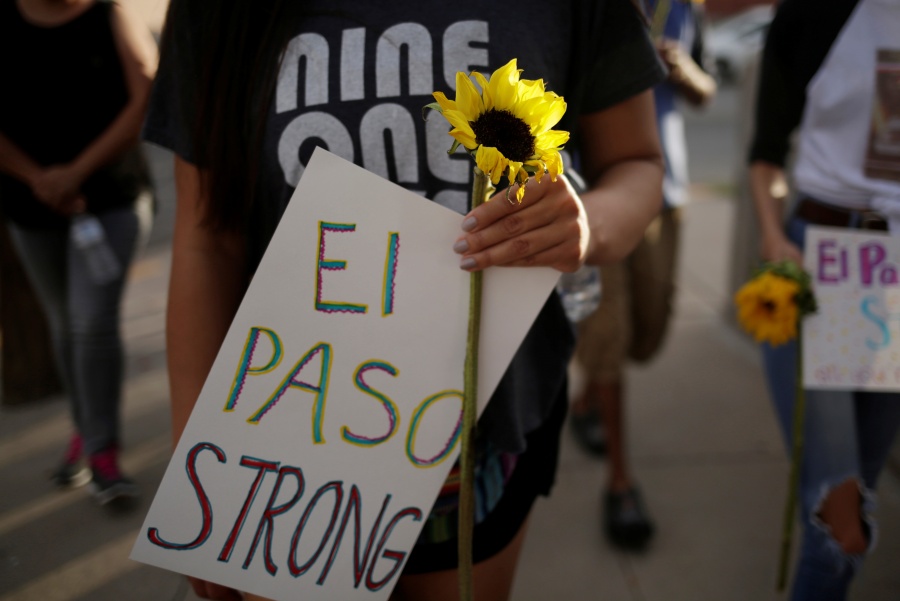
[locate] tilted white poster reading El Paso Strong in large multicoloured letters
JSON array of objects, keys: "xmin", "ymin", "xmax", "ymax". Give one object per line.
[{"xmin": 132, "ymin": 150, "xmax": 559, "ymax": 601}]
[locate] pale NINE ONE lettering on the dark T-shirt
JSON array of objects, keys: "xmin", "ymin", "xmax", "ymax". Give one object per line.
[{"xmin": 274, "ymin": 20, "xmax": 489, "ymax": 212}]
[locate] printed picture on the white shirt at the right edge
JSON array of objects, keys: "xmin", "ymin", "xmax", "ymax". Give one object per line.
[{"xmin": 865, "ymin": 50, "xmax": 900, "ymax": 181}]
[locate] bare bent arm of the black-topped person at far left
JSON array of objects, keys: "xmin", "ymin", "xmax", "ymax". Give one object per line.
[{"xmin": 32, "ymin": 4, "xmax": 157, "ymax": 202}]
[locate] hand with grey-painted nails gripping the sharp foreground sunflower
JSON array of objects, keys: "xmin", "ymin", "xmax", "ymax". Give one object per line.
[{"xmin": 453, "ymin": 175, "xmax": 590, "ymax": 272}]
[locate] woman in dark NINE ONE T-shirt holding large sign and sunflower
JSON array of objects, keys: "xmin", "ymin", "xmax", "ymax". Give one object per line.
[{"xmin": 145, "ymin": 0, "xmax": 663, "ymax": 601}]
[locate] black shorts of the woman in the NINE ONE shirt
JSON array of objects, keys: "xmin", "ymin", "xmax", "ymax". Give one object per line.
[{"xmin": 403, "ymin": 386, "xmax": 568, "ymax": 574}]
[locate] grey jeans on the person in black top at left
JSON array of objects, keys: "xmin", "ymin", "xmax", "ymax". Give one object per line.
[{"xmin": 9, "ymin": 198, "xmax": 152, "ymax": 454}]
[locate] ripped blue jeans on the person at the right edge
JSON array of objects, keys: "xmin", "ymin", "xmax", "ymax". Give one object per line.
[{"xmin": 763, "ymin": 213, "xmax": 900, "ymax": 601}]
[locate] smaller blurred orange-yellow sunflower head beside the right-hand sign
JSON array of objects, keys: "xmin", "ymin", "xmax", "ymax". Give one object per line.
[{"xmin": 734, "ymin": 271, "xmax": 801, "ymax": 346}]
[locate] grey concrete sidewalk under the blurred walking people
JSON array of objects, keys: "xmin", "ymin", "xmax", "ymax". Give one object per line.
[{"xmin": 0, "ymin": 151, "xmax": 900, "ymax": 601}]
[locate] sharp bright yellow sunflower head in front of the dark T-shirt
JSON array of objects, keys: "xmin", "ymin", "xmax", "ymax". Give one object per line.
[{"xmin": 427, "ymin": 59, "xmax": 569, "ymax": 202}]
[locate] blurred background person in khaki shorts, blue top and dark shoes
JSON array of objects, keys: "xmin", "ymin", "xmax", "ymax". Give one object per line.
[{"xmin": 571, "ymin": 0, "xmax": 716, "ymax": 549}]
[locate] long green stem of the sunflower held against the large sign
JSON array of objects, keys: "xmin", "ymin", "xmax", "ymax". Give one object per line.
[{"xmin": 457, "ymin": 167, "xmax": 492, "ymax": 601}]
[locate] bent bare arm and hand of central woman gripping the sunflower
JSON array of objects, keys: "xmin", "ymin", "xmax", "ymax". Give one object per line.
[{"xmin": 454, "ymin": 91, "xmax": 663, "ymax": 272}]
